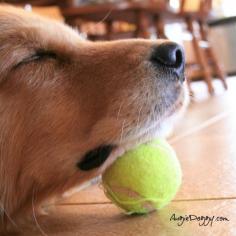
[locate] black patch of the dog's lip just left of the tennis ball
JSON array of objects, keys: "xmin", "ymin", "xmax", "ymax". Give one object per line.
[{"xmin": 77, "ymin": 145, "xmax": 114, "ymax": 171}]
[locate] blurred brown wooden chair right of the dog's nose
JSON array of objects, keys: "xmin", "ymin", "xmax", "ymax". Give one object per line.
[{"xmin": 156, "ymin": 0, "xmax": 227, "ymax": 94}]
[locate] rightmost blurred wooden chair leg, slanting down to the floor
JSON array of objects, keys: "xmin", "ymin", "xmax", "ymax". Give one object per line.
[{"xmin": 199, "ymin": 21, "xmax": 228, "ymax": 89}]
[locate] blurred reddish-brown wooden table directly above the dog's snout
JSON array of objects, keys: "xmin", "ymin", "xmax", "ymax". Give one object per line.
[{"xmin": 62, "ymin": 0, "xmax": 167, "ymax": 40}]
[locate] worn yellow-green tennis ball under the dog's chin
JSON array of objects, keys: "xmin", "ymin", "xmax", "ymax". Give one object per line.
[{"xmin": 102, "ymin": 139, "xmax": 182, "ymax": 214}]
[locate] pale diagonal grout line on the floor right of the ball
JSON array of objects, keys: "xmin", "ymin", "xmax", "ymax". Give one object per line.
[{"xmin": 169, "ymin": 111, "xmax": 232, "ymax": 144}]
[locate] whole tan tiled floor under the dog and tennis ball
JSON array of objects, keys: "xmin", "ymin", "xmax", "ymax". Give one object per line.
[{"xmin": 18, "ymin": 77, "xmax": 236, "ymax": 236}]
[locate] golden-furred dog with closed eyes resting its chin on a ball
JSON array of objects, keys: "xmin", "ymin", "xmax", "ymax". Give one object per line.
[{"xmin": 0, "ymin": 6, "xmax": 188, "ymax": 232}]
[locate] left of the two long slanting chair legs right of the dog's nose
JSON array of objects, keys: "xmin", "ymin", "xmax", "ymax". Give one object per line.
[{"xmin": 186, "ymin": 18, "xmax": 214, "ymax": 95}]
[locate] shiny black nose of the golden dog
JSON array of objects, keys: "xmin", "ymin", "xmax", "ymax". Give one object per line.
[{"xmin": 151, "ymin": 42, "xmax": 185, "ymax": 75}]
